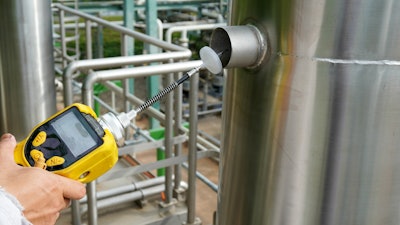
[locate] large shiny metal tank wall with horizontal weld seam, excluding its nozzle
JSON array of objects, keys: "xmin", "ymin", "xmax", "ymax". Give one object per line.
[{"xmin": 217, "ymin": 0, "xmax": 400, "ymax": 225}]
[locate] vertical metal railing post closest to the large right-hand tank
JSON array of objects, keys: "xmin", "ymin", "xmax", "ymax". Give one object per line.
[{"xmin": 187, "ymin": 74, "xmax": 199, "ymax": 224}]
